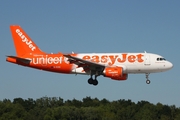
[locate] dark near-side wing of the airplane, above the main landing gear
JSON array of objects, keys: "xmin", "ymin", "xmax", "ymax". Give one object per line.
[{"xmin": 64, "ymin": 54, "xmax": 106, "ymax": 75}]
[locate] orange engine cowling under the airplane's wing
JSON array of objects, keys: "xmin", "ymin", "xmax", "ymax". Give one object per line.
[{"xmin": 103, "ymin": 67, "xmax": 128, "ymax": 80}]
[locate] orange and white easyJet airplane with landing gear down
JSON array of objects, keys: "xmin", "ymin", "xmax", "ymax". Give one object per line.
[{"xmin": 6, "ymin": 25, "xmax": 173, "ymax": 86}]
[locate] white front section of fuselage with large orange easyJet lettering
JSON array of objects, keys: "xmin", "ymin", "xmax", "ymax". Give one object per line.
[{"xmin": 72, "ymin": 53, "xmax": 173, "ymax": 74}]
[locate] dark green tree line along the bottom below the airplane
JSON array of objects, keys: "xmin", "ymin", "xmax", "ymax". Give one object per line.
[{"xmin": 0, "ymin": 97, "xmax": 180, "ymax": 120}]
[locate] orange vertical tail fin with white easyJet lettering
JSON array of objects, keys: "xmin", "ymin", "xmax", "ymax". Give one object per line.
[{"xmin": 10, "ymin": 25, "xmax": 44, "ymax": 57}]
